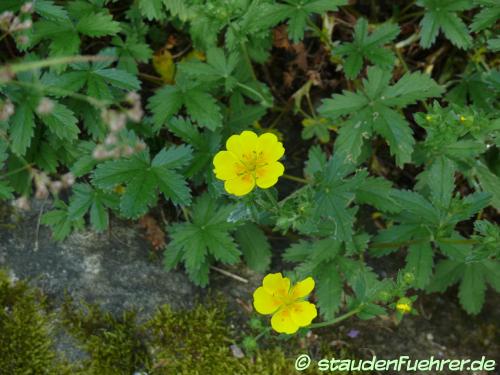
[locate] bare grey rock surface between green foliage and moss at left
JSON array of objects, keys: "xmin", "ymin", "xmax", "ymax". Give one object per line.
[{"xmin": 0, "ymin": 201, "xmax": 199, "ymax": 317}]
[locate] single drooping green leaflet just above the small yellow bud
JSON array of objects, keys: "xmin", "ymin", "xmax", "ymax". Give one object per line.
[{"xmin": 405, "ymin": 240, "xmax": 434, "ymax": 289}]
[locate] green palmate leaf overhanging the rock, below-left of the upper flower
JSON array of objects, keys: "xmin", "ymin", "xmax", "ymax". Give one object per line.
[{"xmin": 165, "ymin": 194, "xmax": 241, "ymax": 286}]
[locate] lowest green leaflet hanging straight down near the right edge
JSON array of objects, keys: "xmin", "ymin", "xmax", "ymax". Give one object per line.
[{"xmin": 458, "ymin": 262, "xmax": 486, "ymax": 315}]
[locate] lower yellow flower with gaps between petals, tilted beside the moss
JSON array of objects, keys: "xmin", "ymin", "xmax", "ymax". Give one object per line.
[{"xmin": 253, "ymin": 273, "xmax": 318, "ymax": 334}]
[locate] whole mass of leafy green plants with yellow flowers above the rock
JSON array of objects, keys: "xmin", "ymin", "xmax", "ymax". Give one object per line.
[{"xmin": 0, "ymin": 0, "xmax": 500, "ymax": 370}]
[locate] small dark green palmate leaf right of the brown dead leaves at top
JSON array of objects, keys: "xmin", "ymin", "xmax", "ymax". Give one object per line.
[{"xmin": 335, "ymin": 18, "xmax": 399, "ymax": 79}]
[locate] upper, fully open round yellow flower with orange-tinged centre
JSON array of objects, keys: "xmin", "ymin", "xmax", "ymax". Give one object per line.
[{"xmin": 214, "ymin": 131, "xmax": 285, "ymax": 196}]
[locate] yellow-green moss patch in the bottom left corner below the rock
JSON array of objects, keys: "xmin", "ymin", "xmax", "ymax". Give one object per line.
[{"xmin": 0, "ymin": 271, "xmax": 69, "ymax": 375}]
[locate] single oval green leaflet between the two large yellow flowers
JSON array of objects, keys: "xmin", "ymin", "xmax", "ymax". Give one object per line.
[{"xmin": 234, "ymin": 223, "xmax": 271, "ymax": 273}]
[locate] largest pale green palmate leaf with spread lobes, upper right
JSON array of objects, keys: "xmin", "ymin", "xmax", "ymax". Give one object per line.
[{"xmin": 319, "ymin": 67, "xmax": 443, "ymax": 166}]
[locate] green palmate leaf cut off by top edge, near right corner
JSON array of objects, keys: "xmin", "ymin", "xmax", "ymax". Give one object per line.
[{"xmin": 417, "ymin": 0, "xmax": 473, "ymax": 49}]
